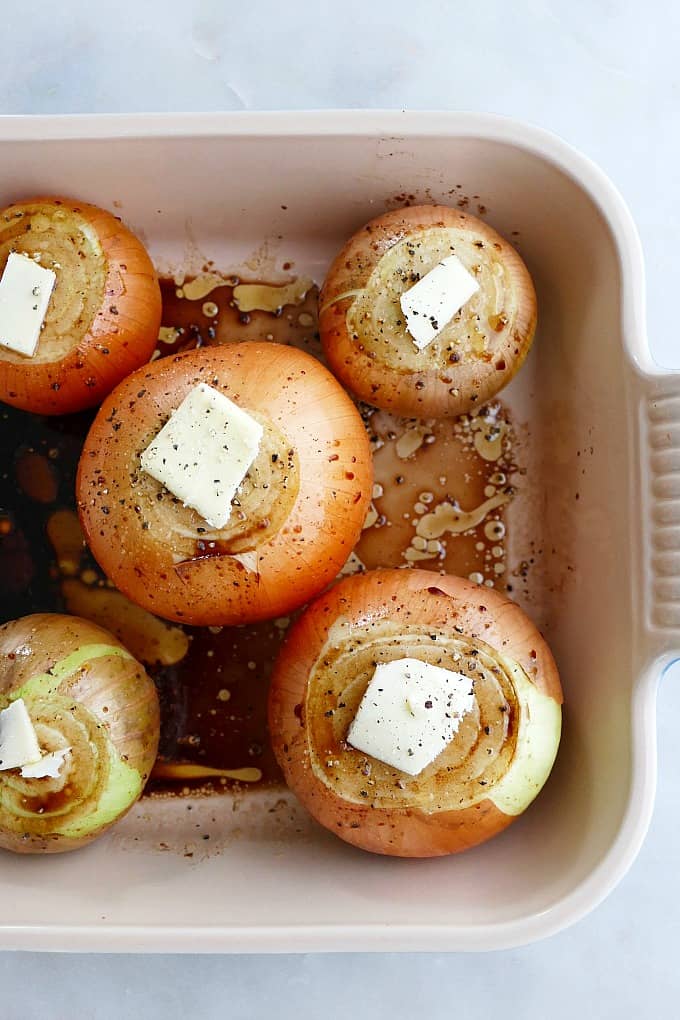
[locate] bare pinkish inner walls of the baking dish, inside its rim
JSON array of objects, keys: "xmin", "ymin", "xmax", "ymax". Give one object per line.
[{"xmin": 0, "ymin": 129, "xmax": 639, "ymax": 950}]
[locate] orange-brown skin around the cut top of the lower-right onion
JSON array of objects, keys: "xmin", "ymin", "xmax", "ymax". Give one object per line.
[{"xmin": 269, "ymin": 569, "xmax": 562, "ymax": 857}]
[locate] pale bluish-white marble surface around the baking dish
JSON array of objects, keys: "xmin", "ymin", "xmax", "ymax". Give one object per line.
[{"xmin": 0, "ymin": 0, "xmax": 680, "ymax": 1020}]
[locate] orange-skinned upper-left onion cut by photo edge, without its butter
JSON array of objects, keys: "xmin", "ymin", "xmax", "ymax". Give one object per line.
[{"xmin": 0, "ymin": 198, "xmax": 161, "ymax": 414}]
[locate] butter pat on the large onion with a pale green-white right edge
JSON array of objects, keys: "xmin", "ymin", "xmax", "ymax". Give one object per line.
[{"xmin": 347, "ymin": 659, "xmax": 475, "ymax": 775}]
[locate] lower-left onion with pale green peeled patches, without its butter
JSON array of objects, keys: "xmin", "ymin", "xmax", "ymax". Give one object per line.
[{"xmin": 0, "ymin": 613, "xmax": 160, "ymax": 854}]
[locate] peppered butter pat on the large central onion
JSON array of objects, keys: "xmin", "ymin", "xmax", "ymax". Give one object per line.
[{"xmin": 141, "ymin": 383, "xmax": 263, "ymax": 527}]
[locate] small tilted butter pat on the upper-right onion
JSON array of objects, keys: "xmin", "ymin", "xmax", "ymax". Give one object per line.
[{"xmin": 399, "ymin": 255, "xmax": 479, "ymax": 351}]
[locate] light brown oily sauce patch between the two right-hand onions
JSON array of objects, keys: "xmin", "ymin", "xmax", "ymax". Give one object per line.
[{"xmin": 356, "ymin": 402, "xmax": 516, "ymax": 588}]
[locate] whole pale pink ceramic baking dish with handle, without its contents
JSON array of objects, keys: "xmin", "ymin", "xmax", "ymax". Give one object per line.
[{"xmin": 0, "ymin": 112, "xmax": 680, "ymax": 952}]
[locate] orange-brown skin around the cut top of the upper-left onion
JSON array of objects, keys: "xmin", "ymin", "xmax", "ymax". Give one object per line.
[{"xmin": 0, "ymin": 197, "xmax": 161, "ymax": 414}]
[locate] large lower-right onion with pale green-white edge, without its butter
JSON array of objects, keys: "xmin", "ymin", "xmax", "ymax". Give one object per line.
[{"xmin": 269, "ymin": 570, "xmax": 562, "ymax": 857}]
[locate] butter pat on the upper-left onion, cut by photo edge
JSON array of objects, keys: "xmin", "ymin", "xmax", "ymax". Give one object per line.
[{"xmin": 0, "ymin": 252, "xmax": 57, "ymax": 358}]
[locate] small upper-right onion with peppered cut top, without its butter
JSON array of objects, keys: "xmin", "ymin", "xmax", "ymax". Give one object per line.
[{"xmin": 319, "ymin": 205, "xmax": 536, "ymax": 418}]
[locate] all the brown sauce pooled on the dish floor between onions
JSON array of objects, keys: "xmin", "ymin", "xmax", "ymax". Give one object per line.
[{"xmin": 0, "ymin": 267, "xmax": 518, "ymax": 795}]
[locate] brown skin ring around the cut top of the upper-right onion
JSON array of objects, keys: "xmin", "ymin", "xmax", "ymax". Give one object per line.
[{"xmin": 319, "ymin": 205, "xmax": 536, "ymax": 418}]
